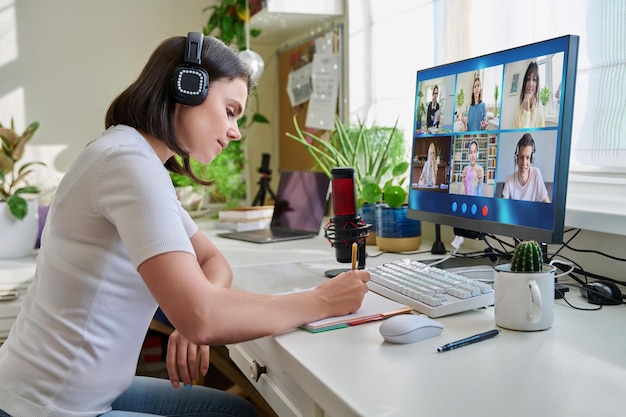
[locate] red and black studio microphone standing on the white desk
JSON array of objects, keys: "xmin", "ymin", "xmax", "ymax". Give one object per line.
[{"xmin": 324, "ymin": 167, "xmax": 369, "ymax": 277}]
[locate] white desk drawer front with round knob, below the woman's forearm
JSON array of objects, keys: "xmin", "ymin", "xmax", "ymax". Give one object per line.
[{"xmin": 228, "ymin": 337, "xmax": 318, "ymax": 417}]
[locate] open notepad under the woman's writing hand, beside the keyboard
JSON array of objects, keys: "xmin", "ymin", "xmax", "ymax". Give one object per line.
[{"xmin": 300, "ymin": 291, "xmax": 412, "ymax": 333}]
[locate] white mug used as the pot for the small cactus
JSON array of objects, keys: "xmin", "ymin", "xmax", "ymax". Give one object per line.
[{"xmin": 494, "ymin": 264, "xmax": 556, "ymax": 331}]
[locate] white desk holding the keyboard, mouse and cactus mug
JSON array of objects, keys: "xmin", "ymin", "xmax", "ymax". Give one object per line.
[{"xmin": 0, "ymin": 221, "xmax": 626, "ymax": 417}]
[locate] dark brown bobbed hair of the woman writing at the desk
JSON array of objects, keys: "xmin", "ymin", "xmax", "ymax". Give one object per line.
[{"xmin": 104, "ymin": 36, "xmax": 252, "ymax": 185}]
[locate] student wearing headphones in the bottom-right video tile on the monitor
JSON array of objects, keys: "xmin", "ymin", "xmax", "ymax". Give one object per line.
[{"xmin": 502, "ymin": 133, "xmax": 550, "ymax": 203}]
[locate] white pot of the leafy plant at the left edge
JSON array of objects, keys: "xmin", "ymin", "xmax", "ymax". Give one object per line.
[{"xmin": 0, "ymin": 200, "xmax": 39, "ymax": 259}]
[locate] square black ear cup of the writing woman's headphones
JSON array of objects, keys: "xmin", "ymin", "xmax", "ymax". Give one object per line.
[{"xmin": 172, "ymin": 64, "xmax": 209, "ymax": 106}]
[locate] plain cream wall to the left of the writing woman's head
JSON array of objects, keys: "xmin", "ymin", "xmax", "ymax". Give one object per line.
[{"xmin": 0, "ymin": 0, "xmax": 210, "ymax": 182}]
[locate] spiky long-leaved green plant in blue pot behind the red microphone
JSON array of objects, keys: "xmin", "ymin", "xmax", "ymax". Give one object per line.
[{"xmin": 287, "ymin": 116, "xmax": 406, "ymax": 244}]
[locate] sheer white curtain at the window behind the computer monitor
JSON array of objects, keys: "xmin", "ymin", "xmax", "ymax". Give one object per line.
[{"xmin": 434, "ymin": 0, "xmax": 626, "ymax": 174}]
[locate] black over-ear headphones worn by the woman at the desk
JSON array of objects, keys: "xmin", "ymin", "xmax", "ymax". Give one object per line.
[{"xmin": 172, "ymin": 32, "xmax": 209, "ymax": 106}]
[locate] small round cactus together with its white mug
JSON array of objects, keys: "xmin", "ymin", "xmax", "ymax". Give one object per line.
[{"xmin": 494, "ymin": 240, "xmax": 556, "ymax": 331}]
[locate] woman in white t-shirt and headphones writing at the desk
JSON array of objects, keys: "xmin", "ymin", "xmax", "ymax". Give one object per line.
[{"xmin": 0, "ymin": 34, "xmax": 369, "ymax": 417}]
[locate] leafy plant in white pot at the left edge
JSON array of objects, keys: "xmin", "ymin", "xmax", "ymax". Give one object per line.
[{"xmin": 0, "ymin": 119, "xmax": 43, "ymax": 258}]
